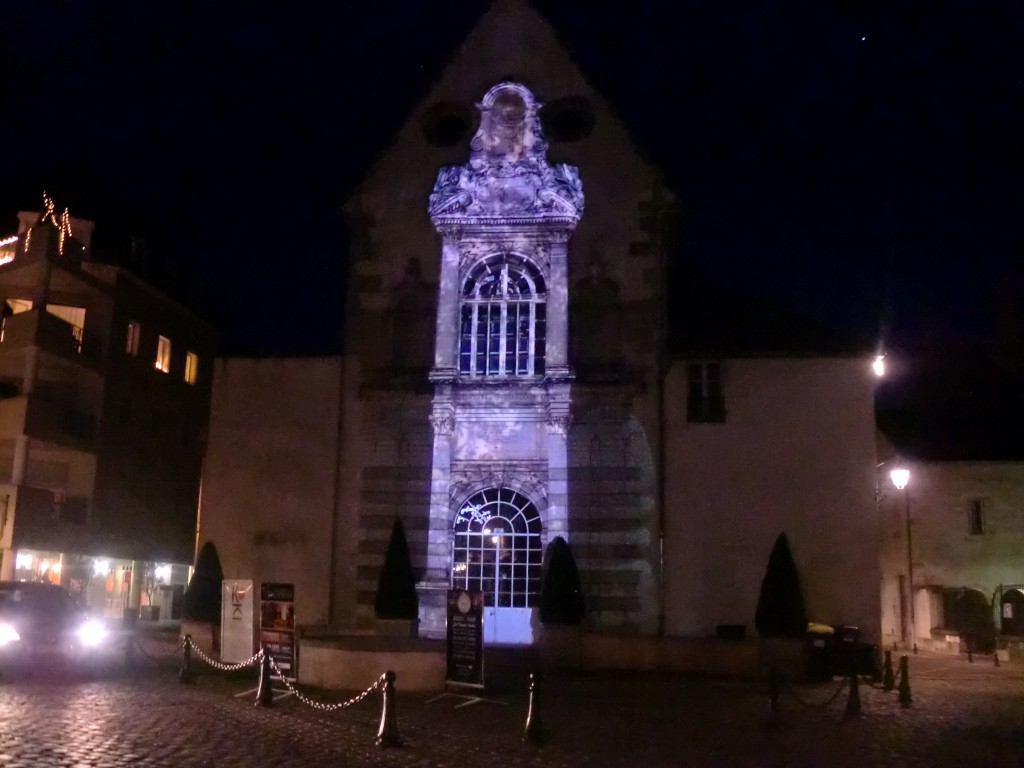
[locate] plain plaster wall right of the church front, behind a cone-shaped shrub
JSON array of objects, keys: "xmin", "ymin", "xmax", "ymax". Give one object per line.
[{"xmin": 666, "ymin": 358, "xmax": 880, "ymax": 642}]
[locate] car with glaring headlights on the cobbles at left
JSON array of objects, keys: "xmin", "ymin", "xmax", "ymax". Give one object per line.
[{"xmin": 0, "ymin": 582, "xmax": 106, "ymax": 669}]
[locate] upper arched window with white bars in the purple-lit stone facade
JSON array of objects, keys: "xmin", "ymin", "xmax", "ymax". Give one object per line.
[{"xmin": 459, "ymin": 254, "xmax": 546, "ymax": 377}]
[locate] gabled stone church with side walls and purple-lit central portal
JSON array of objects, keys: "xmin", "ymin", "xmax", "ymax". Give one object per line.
[{"xmin": 200, "ymin": 0, "xmax": 880, "ymax": 643}]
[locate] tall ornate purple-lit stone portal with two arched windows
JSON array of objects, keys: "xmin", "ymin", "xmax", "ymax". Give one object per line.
[{"xmin": 420, "ymin": 83, "xmax": 584, "ymax": 642}]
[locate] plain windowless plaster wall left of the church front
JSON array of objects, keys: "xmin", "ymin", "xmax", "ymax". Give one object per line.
[{"xmin": 200, "ymin": 357, "xmax": 342, "ymax": 624}]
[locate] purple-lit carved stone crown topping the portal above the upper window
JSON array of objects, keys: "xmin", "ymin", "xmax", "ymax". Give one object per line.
[{"xmin": 428, "ymin": 83, "xmax": 584, "ymax": 232}]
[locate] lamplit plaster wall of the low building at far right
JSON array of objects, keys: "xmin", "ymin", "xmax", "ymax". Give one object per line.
[{"xmin": 879, "ymin": 461, "xmax": 1024, "ymax": 638}]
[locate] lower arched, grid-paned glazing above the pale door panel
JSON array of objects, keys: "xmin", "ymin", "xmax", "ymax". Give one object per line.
[{"xmin": 452, "ymin": 488, "xmax": 543, "ymax": 608}]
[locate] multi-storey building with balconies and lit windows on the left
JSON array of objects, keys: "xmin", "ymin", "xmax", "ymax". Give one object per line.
[{"xmin": 0, "ymin": 204, "xmax": 215, "ymax": 616}]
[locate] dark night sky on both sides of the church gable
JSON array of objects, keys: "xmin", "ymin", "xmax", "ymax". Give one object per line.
[{"xmin": 0, "ymin": 0, "xmax": 1024, "ymax": 364}]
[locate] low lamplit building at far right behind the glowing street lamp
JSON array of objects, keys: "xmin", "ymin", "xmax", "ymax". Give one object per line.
[{"xmin": 879, "ymin": 455, "xmax": 1024, "ymax": 650}]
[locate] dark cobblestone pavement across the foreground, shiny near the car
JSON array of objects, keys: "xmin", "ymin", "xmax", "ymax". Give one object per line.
[{"xmin": 0, "ymin": 644, "xmax": 1024, "ymax": 768}]
